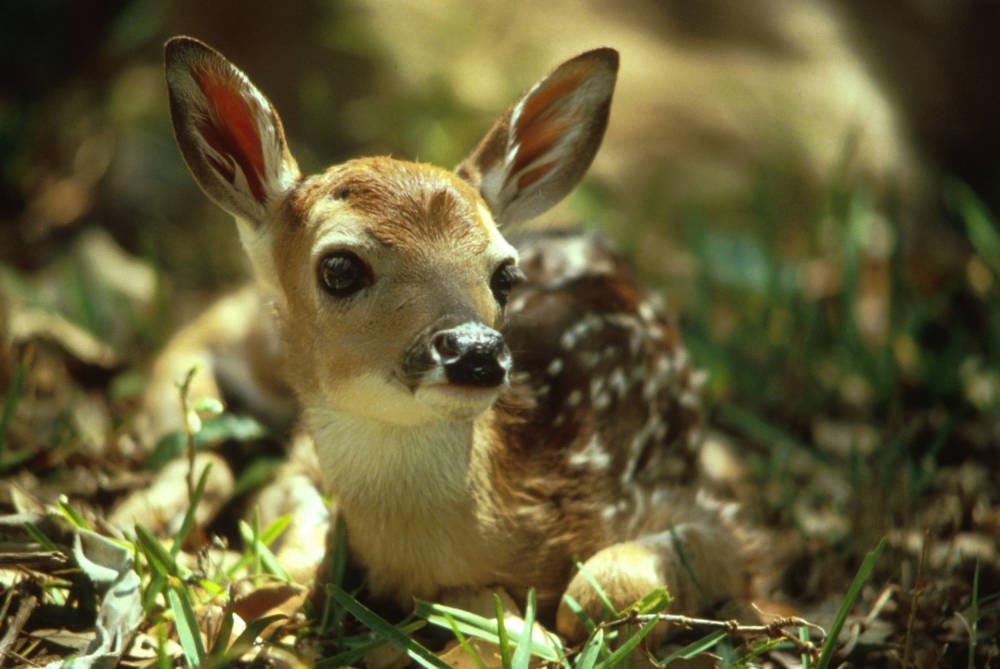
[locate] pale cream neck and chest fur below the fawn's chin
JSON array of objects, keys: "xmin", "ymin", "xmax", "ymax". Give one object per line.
[{"xmin": 305, "ymin": 410, "xmax": 508, "ymax": 607}]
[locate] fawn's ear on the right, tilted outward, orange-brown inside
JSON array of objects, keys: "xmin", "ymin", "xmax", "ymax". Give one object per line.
[{"xmin": 456, "ymin": 49, "xmax": 618, "ymax": 225}]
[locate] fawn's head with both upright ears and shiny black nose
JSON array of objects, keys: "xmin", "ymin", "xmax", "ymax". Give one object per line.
[{"xmin": 166, "ymin": 37, "xmax": 618, "ymax": 425}]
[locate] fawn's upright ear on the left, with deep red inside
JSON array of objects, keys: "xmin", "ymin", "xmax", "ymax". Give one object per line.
[{"xmin": 165, "ymin": 37, "xmax": 301, "ymax": 227}]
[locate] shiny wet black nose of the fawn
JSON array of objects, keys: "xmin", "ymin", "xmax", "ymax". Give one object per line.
[{"xmin": 431, "ymin": 323, "xmax": 510, "ymax": 388}]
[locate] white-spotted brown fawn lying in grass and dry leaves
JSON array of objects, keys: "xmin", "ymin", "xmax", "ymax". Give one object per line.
[{"xmin": 166, "ymin": 37, "xmax": 749, "ymax": 638}]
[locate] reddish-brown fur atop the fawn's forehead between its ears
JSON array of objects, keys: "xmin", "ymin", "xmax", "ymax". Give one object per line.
[{"xmin": 290, "ymin": 158, "xmax": 494, "ymax": 247}]
